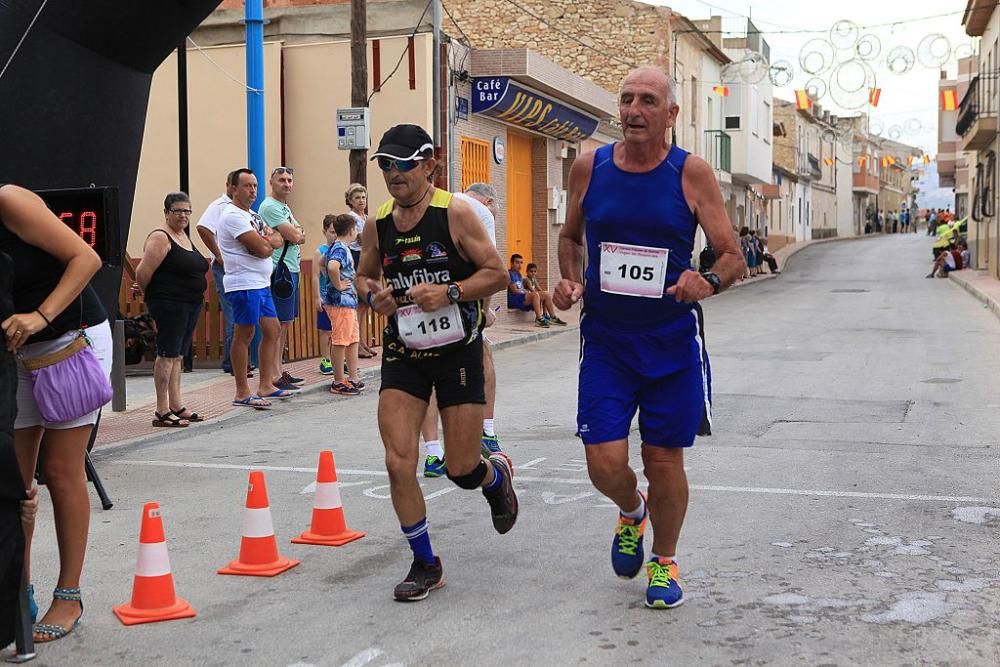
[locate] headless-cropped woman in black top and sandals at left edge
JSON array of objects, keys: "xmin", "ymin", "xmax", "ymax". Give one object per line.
[{"xmin": 0, "ymin": 184, "xmax": 110, "ymax": 642}]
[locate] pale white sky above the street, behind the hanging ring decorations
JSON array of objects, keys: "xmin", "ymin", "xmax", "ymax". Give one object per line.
[{"xmin": 644, "ymin": 0, "xmax": 978, "ymax": 154}]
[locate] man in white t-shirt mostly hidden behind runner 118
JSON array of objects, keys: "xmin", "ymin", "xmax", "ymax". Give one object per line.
[{"xmin": 420, "ymin": 183, "xmax": 501, "ymax": 477}]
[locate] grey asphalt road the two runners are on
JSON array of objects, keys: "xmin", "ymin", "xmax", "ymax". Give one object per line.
[{"xmin": 23, "ymin": 235, "xmax": 1000, "ymax": 667}]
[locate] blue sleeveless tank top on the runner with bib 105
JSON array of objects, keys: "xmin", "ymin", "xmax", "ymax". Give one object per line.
[{"xmin": 583, "ymin": 145, "xmax": 697, "ymax": 330}]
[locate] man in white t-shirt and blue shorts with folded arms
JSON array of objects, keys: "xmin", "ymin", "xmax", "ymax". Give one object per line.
[{"xmin": 216, "ymin": 169, "xmax": 293, "ymax": 410}]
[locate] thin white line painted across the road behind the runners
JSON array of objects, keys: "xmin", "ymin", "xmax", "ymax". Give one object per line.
[{"xmin": 112, "ymin": 460, "xmax": 1000, "ymax": 505}]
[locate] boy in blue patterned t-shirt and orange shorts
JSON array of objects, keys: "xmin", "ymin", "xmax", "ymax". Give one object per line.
[{"xmin": 323, "ymin": 213, "xmax": 365, "ymax": 396}]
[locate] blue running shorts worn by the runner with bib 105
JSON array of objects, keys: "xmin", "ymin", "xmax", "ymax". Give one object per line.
[{"xmin": 577, "ymin": 306, "xmax": 712, "ymax": 447}]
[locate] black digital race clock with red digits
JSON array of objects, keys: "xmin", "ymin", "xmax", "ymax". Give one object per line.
[{"xmin": 36, "ymin": 187, "xmax": 122, "ymax": 266}]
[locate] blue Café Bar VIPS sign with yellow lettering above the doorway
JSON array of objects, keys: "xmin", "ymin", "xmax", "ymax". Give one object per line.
[{"xmin": 472, "ymin": 76, "xmax": 598, "ymax": 142}]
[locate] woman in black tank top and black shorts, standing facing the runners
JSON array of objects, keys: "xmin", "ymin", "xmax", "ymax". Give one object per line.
[{"xmin": 135, "ymin": 192, "xmax": 208, "ymax": 428}]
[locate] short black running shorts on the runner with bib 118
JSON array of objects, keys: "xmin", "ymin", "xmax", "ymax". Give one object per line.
[{"xmin": 379, "ymin": 336, "xmax": 486, "ymax": 410}]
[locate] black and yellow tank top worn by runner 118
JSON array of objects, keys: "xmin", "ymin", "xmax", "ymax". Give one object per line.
[{"xmin": 375, "ymin": 190, "xmax": 484, "ymax": 359}]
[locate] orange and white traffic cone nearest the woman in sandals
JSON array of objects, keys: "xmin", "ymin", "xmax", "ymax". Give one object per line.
[{"xmin": 113, "ymin": 503, "xmax": 195, "ymax": 625}]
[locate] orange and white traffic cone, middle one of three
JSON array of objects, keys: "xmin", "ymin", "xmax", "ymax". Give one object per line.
[{"xmin": 219, "ymin": 471, "xmax": 299, "ymax": 577}]
